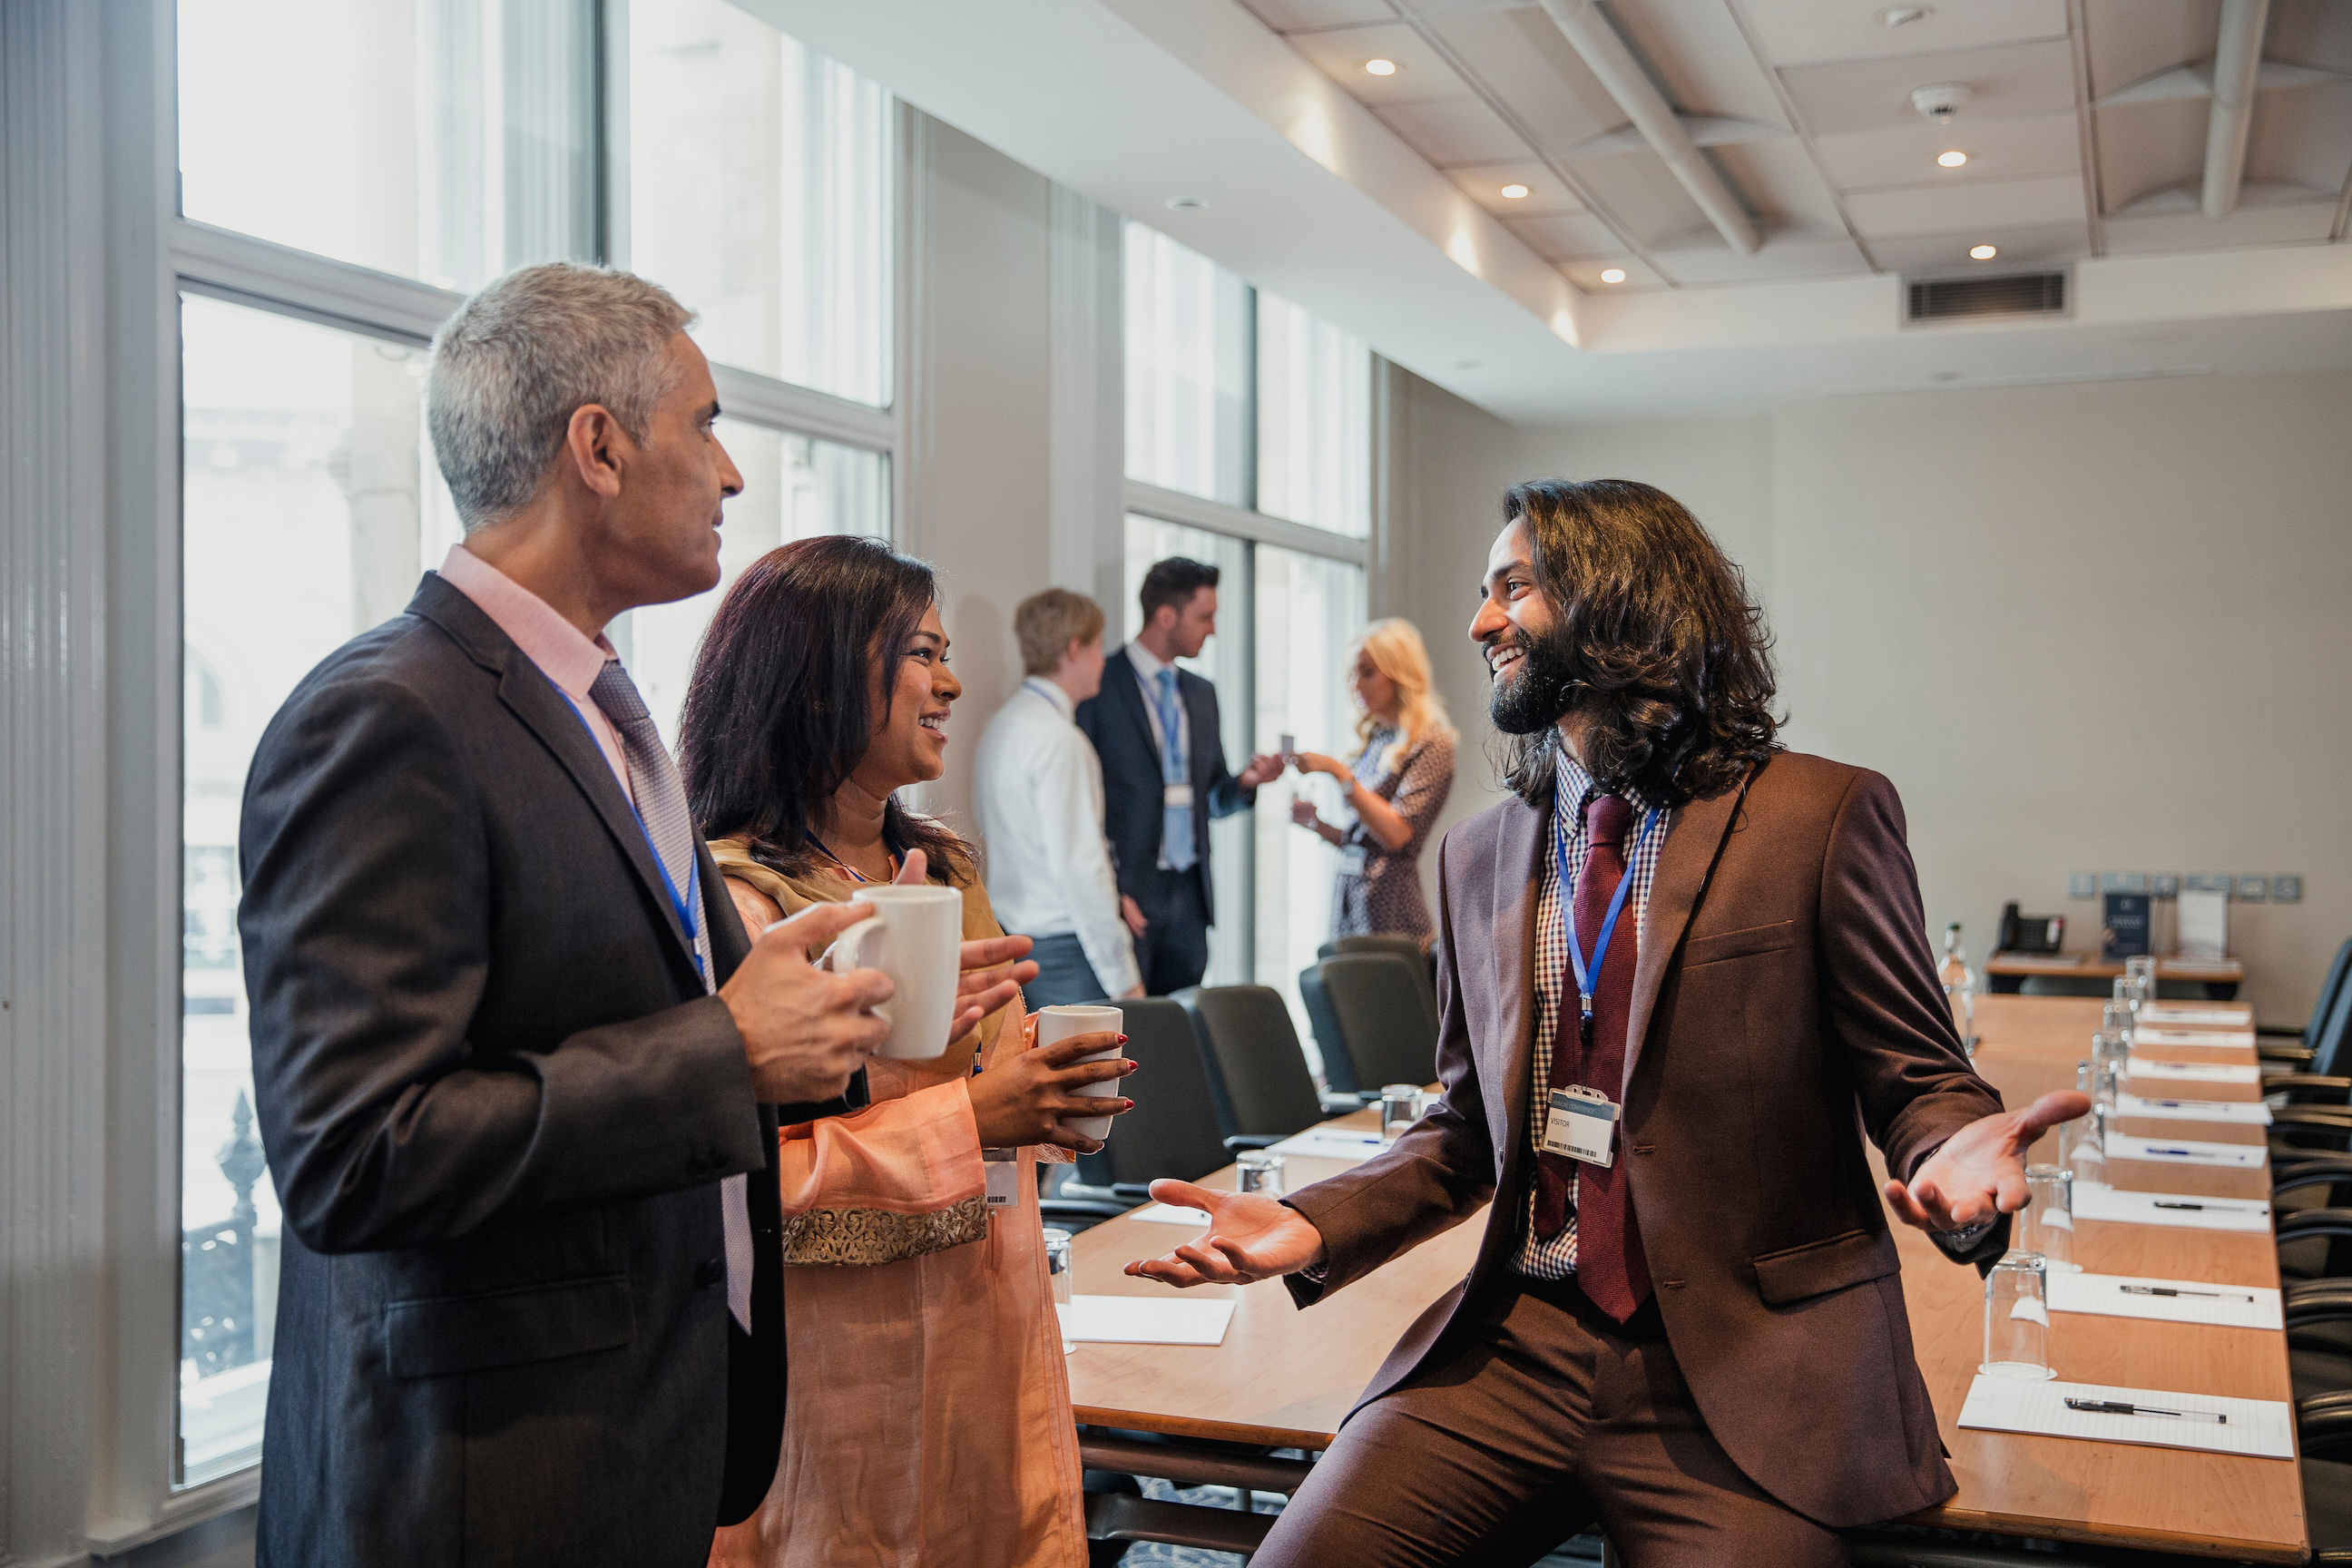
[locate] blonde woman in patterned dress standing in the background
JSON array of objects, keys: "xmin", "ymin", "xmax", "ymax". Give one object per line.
[{"xmin": 1291, "ymin": 618, "xmax": 1458, "ymax": 947}]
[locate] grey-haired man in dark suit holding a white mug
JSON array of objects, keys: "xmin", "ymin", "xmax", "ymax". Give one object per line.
[{"xmin": 240, "ymin": 263, "xmax": 1025, "ymax": 1568}]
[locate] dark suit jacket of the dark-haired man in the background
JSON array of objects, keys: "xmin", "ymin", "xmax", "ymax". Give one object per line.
[{"xmin": 1077, "ymin": 646, "xmax": 1259, "ymax": 924}]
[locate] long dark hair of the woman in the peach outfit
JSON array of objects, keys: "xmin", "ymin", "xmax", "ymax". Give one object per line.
[{"xmin": 677, "ymin": 536, "xmax": 971, "ymax": 882}]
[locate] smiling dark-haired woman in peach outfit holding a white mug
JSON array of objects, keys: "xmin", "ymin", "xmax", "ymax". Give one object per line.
[{"xmin": 680, "ymin": 538, "xmax": 1133, "ymax": 1568}]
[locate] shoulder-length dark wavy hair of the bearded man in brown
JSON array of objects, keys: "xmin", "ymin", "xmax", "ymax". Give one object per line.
[{"xmin": 1501, "ymin": 480, "xmax": 1780, "ymax": 807}]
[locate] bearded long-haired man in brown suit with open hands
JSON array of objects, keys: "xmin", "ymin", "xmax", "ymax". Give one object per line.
[{"xmin": 1129, "ymin": 480, "xmax": 2086, "ymax": 1568}]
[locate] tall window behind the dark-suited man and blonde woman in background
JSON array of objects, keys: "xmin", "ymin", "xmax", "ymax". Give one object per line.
[{"xmin": 1122, "ymin": 223, "xmax": 1371, "ymax": 1051}]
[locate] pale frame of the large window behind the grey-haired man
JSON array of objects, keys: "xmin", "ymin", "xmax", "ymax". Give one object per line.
[{"xmin": 103, "ymin": 0, "xmax": 929, "ymax": 1553}]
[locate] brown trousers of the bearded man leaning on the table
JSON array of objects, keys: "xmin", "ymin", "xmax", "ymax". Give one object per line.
[{"xmin": 1251, "ymin": 1281, "xmax": 1847, "ymax": 1568}]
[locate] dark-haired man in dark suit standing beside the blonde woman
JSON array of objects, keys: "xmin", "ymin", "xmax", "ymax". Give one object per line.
[{"xmin": 1077, "ymin": 554, "xmax": 1282, "ymax": 996}]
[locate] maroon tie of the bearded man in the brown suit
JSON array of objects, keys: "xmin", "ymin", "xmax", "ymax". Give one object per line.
[{"xmin": 1536, "ymin": 795, "xmax": 1649, "ymax": 1324}]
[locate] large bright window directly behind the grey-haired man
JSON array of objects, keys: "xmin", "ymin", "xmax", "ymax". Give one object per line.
[{"xmin": 156, "ymin": 0, "xmax": 898, "ymax": 1485}]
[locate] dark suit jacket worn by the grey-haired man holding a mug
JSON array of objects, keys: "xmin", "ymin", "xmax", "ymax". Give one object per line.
[{"xmin": 238, "ymin": 573, "xmax": 863, "ymax": 1568}]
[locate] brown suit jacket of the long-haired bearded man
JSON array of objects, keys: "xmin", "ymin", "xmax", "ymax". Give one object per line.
[{"xmin": 1289, "ymin": 755, "xmax": 2009, "ymax": 1528}]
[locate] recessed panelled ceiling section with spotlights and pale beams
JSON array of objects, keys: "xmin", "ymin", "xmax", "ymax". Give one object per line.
[{"xmin": 1244, "ymin": 0, "xmax": 2352, "ymax": 291}]
